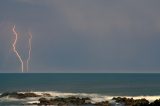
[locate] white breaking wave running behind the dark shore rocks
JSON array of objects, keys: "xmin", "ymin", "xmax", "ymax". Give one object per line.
[{"xmin": 21, "ymin": 91, "xmax": 160, "ymax": 103}]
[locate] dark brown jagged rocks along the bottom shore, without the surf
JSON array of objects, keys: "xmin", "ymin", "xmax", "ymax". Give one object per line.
[{"xmin": 0, "ymin": 92, "xmax": 160, "ymax": 106}]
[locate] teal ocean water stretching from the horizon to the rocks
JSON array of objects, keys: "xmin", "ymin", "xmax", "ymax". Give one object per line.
[{"xmin": 0, "ymin": 73, "xmax": 160, "ymax": 104}]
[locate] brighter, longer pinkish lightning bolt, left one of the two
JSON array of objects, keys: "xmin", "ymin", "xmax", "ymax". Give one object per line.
[{"xmin": 12, "ymin": 25, "xmax": 24, "ymax": 72}]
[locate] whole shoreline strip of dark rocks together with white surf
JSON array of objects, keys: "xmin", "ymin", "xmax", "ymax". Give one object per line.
[{"xmin": 0, "ymin": 91, "xmax": 160, "ymax": 106}]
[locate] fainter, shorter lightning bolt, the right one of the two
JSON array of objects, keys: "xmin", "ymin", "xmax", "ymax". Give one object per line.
[{"xmin": 27, "ymin": 32, "xmax": 32, "ymax": 71}]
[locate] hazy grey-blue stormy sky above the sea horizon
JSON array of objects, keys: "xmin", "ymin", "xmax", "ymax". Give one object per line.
[{"xmin": 0, "ymin": 0, "xmax": 160, "ymax": 73}]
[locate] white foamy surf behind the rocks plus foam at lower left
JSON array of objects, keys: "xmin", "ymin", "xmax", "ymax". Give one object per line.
[{"xmin": 0, "ymin": 91, "xmax": 160, "ymax": 103}]
